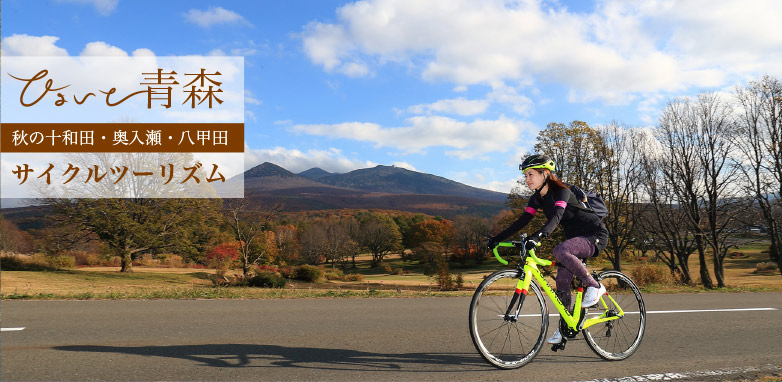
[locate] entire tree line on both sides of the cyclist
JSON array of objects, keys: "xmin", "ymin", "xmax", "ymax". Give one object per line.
[{"xmin": 6, "ymin": 76, "xmax": 782, "ymax": 288}]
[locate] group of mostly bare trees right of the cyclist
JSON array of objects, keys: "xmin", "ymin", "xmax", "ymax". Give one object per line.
[{"xmin": 528, "ymin": 76, "xmax": 782, "ymax": 288}]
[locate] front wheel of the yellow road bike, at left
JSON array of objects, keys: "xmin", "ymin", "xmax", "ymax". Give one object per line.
[{"xmin": 469, "ymin": 270, "xmax": 548, "ymax": 369}]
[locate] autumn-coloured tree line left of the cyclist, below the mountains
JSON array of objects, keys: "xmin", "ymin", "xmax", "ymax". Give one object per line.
[{"xmin": 0, "ymin": 194, "xmax": 496, "ymax": 276}]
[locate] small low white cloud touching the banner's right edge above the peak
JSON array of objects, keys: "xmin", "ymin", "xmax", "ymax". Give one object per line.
[{"xmin": 244, "ymin": 145, "xmax": 378, "ymax": 173}]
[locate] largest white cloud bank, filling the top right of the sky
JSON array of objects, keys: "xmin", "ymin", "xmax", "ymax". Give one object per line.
[{"xmin": 301, "ymin": 0, "xmax": 782, "ymax": 103}]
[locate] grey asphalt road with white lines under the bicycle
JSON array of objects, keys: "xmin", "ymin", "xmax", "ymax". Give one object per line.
[{"xmin": 0, "ymin": 293, "xmax": 782, "ymax": 381}]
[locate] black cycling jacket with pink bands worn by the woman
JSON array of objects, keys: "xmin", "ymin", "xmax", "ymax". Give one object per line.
[{"xmin": 493, "ymin": 183, "xmax": 608, "ymax": 254}]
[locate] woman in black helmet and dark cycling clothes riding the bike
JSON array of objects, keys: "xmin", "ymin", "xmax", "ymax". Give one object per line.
[{"xmin": 489, "ymin": 155, "xmax": 608, "ymax": 344}]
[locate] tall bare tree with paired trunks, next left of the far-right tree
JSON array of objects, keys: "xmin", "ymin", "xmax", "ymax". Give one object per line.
[{"xmin": 660, "ymin": 93, "xmax": 741, "ymax": 288}]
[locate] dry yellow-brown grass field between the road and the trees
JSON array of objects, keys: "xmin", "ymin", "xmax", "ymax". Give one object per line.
[{"xmin": 0, "ymin": 245, "xmax": 782, "ymax": 299}]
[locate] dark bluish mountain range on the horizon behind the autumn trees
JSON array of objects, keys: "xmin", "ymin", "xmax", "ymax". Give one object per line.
[{"xmin": 239, "ymin": 162, "xmax": 507, "ymax": 218}]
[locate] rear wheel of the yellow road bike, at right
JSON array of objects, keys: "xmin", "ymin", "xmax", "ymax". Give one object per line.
[{"xmin": 583, "ymin": 271, "xmax": 646, "ymax": 361}]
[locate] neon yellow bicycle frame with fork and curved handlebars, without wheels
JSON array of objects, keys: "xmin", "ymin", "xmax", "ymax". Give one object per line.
[{"xmin": 492, "ymin": 241, "xmax": 625, "ymax": 330}]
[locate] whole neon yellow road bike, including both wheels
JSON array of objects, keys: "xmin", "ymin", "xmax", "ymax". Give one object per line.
[{"xmin": 469, "ymin": 237, "xmax": 646, "ymax": 369}]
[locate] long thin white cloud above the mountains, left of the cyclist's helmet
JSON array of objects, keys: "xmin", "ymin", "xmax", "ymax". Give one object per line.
[{"xmin": 291, "ymin": 116, "xmax": 532, "ymax": 159}]
